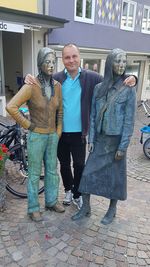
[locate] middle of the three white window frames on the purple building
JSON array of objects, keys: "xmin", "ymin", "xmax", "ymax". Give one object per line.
[{"xmin": 120, "ymin": 0, "xmax": 137, "ymax": 31}]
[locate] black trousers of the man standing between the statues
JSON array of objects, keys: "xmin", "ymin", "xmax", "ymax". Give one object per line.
[{"xmin": 58, "ymin": 132, "xmax": 86, "ymax": 198}]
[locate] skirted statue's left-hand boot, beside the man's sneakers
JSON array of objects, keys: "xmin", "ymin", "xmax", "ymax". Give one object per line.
[{"xmin": 71, "ymin": 194, "xmax": 91, "ymax": 221}]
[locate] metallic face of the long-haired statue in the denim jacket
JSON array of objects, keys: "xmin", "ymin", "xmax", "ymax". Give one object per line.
[{"xmin": 113, "ymin": 53, "xmax": 127, "ymax": 75}]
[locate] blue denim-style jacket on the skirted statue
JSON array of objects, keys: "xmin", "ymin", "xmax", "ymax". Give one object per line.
[{"xmin": 89, "ymin": 80, "xmax": 136, "ymax": 151}]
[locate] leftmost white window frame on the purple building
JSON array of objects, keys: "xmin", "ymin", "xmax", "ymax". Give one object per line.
[{"xmin": 74, "ymin": 0, "xmax": 95, "ymax": 24}]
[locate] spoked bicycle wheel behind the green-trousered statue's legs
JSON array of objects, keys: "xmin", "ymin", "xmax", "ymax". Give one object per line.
[{"xmin": 5, "ymin": 144, "xmax": 44, "ymax": 198}]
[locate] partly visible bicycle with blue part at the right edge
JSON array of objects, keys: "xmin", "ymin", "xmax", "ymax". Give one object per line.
[{"xmin": 138, "ymin": 100, "xmax": 150, "ymax": 159}]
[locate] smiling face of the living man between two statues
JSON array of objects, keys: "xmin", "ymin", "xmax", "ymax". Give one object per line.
[{"xmin": 62, "ymin": 46, "xmax": 80, "ymax": 73}]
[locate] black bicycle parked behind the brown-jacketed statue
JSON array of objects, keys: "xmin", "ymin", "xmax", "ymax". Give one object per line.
[{"xmin": 0, "ymin": 108, "xmax": 44, "ymax": 198}]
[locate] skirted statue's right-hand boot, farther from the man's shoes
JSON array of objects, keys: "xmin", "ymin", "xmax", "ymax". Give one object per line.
[{"xmin": 101, "ymin": 199, "xmax": 117, "ymax": 225}]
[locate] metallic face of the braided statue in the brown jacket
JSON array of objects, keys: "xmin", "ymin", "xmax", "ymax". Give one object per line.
[{"xmin": 41, "ymin": 53, "xmax": 55, "ymax": 76}]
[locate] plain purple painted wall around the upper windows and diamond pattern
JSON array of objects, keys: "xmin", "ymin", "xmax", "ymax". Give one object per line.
[{"xmin": 49, "ymin": 0, "xmax": 150, "ymax": 53}]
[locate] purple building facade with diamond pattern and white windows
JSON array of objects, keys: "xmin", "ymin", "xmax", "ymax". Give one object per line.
[{"xmin": 48, "ymin": 0, "xmax": 150, "ymax": 100}]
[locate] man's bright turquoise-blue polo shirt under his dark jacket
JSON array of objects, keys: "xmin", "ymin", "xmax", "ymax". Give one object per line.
[{"xmin": 62, "ymin": 68, "xmax": 81, "ymax": 132}]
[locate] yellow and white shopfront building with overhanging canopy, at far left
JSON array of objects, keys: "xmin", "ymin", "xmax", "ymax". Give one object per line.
[{"xmin": 0, "ymin": 0, "xmax": 67, "ymax": 116}]
